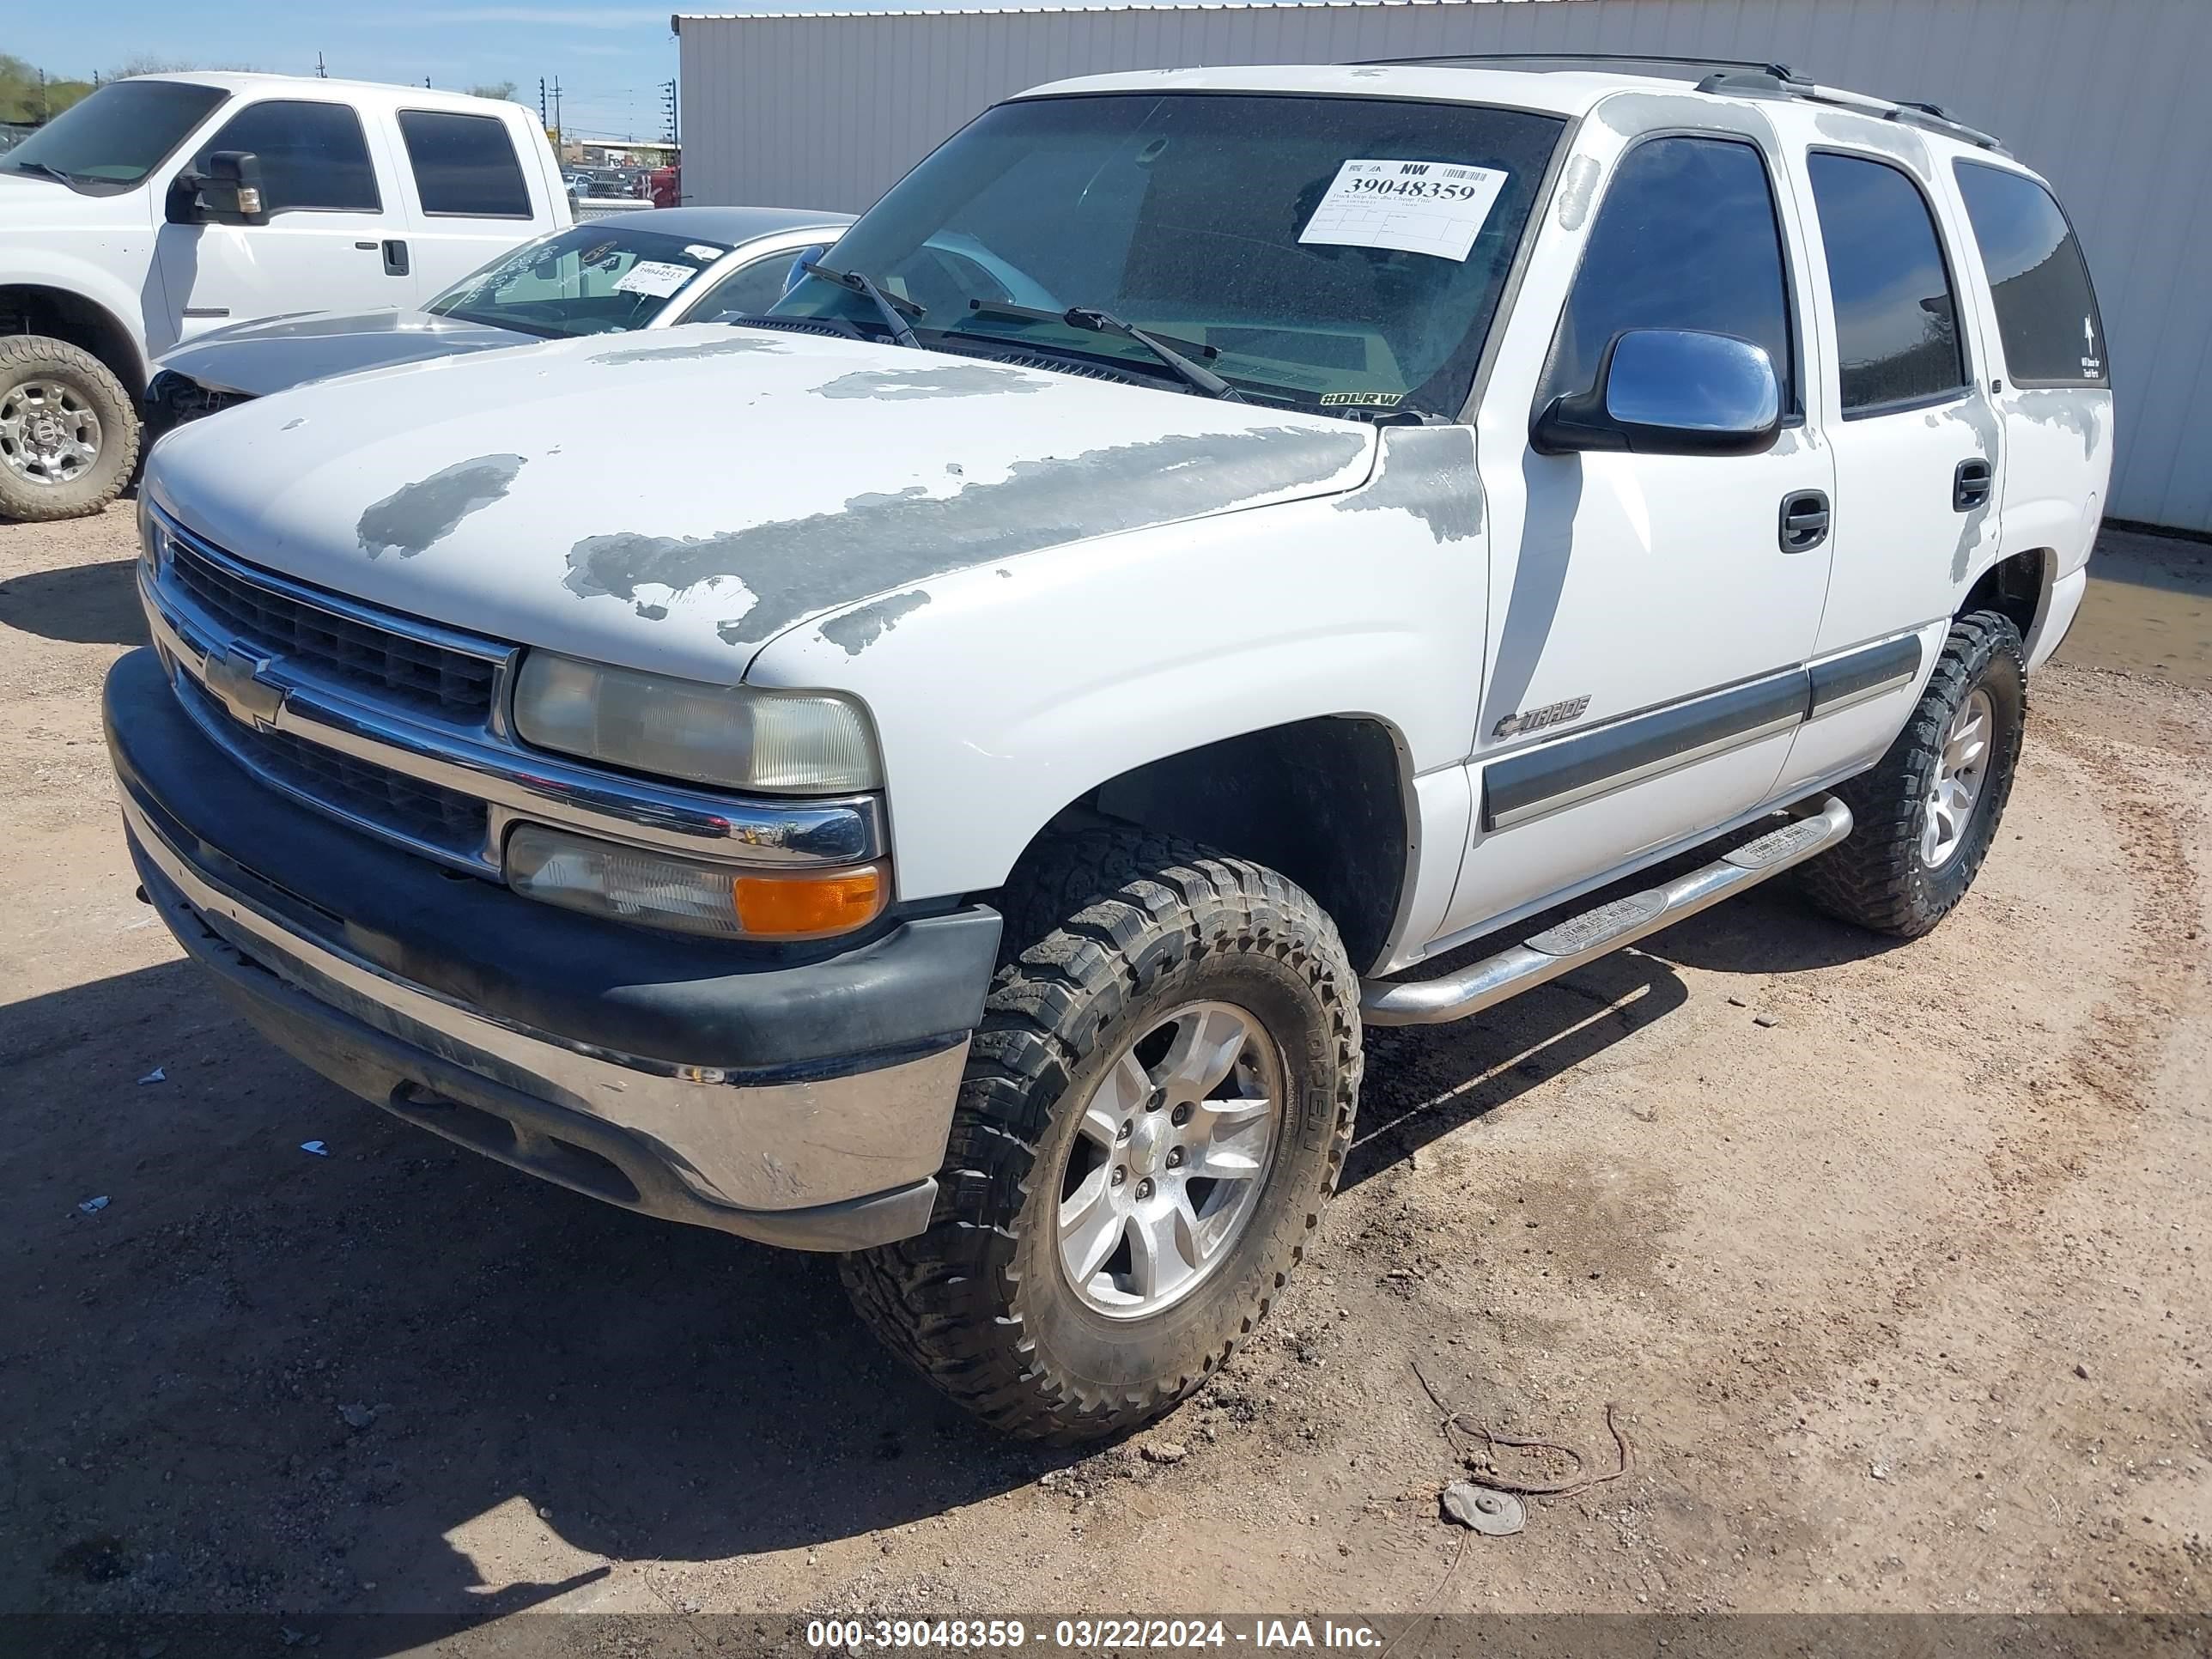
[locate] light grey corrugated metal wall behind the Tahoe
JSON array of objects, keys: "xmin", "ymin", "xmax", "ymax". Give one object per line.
[{"xmin": 681, "ymin": 0, "xmax": 2212, "ymax": 531}]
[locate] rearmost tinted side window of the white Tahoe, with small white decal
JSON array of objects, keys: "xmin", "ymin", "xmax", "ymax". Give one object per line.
[{"xmin": 1955, "ymin": 161, "xmax": 2112, "ymax": 385}]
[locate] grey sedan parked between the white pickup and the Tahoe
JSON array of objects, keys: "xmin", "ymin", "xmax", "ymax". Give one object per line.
[{"xmin": 143, "ymin": 208, "xmax": 852, "ymax": 442}]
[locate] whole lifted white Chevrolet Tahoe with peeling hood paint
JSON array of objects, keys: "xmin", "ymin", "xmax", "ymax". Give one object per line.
[{"xmin": 106, "ymin": 62, "xmax": 2112, "ymax": 1440}]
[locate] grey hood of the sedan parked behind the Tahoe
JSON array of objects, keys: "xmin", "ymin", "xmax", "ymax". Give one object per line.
[{"xmin": 155, "ymin": 312, "xmax": 535, "ymax": 398}]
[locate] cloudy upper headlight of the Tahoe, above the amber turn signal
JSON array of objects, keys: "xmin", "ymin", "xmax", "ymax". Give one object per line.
[{"xmin": 515, "ymin": 650, "xmax": 883, "ymax": 794}]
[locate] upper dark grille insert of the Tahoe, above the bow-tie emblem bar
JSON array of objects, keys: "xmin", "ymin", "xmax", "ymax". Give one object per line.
[{"xmin": 168, "ymin": 538, "xmax": 498, "ymax": 726}]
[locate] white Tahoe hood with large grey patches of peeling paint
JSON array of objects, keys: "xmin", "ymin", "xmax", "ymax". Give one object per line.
[{"xmin": 146, "ymin": 323, "xmax": 1374, "ymax": 679}]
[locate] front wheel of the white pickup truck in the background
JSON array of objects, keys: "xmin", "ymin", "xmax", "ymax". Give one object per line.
[{"xmin": 0, "ymin": 334, "xmax": 137, "ymax": 522}]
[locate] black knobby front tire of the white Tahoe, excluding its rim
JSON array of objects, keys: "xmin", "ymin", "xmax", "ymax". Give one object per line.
[{"xmin": 842, "ymin": 827, "xmax": 1360, "ymax": 1444}]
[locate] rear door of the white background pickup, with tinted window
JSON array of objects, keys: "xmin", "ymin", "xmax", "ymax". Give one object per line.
[{"xmin": 382, "ymin": 108, "xmax": 553, "ymax": 299}]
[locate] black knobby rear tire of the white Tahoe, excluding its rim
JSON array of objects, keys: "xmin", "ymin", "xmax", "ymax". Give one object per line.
[{"xmin": 1801, "ymin": 611, "xmax": 2028, "ymax": 938}]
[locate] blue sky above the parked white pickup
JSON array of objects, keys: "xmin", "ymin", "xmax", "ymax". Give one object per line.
[{"xmin": 13, "ymin": 0, "xmax": 690, "ymax": 137}]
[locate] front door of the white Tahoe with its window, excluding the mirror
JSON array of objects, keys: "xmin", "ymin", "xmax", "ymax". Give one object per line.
[{"xmin": 1444, "ymin": 115, "xmax": 1834, "ymax": 942}]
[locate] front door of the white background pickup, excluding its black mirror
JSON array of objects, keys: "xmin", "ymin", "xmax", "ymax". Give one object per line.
[{"xmin": 155, "ymin": 97, "xmax": 414, "ymax": 341}]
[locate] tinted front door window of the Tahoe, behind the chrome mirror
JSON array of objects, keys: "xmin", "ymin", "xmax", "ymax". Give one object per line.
[{"xmin": 1537, "ymin": 137, "xmax": 1798, "ymax": 410}]
